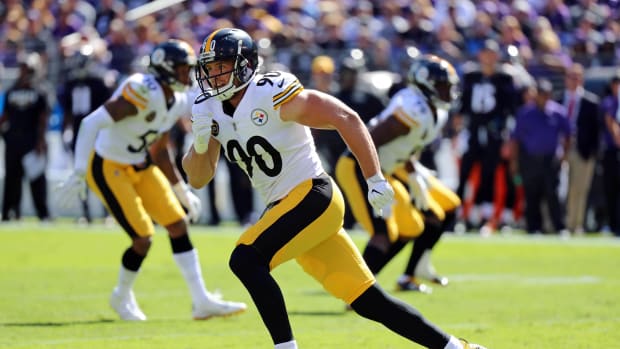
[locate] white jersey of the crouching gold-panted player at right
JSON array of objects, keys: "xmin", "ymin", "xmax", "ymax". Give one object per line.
[{"xmin": 371, "ymin": 87, "xmax": 448, "ymax": 173}]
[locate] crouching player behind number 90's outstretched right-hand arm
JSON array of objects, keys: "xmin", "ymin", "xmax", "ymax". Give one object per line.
[{"xmin": 336, "ymin": 55, "xmax": 461, "ymax": 292}]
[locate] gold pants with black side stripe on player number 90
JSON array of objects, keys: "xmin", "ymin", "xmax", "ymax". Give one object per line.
[{"xmin": 237, "ymin": 176, "xmax": 375, "ymax": 303}]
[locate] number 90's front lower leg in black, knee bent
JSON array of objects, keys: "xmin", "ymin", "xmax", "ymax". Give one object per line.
[{"xmin": 229, "ymin": 244, "xmax": 293, "ymax": 344}]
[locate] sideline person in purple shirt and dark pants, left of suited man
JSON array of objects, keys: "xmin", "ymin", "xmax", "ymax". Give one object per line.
[{"xmin": 511, "ymin": 79, "xmax": 570, "ymax": 234}]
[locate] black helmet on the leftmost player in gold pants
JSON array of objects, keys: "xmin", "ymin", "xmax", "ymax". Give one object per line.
[{"xmin": 148, "ymin": 39, "xmax": 196, "ymax": 91}]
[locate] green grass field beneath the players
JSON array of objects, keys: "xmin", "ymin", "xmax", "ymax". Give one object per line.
[{"xmin": 0, "ymin": 222, "xmax": 620, "ymax": 349}]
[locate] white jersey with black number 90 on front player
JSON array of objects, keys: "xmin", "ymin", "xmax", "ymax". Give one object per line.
[{"xmin": 192, "ymin": 71, "xmax": 325, "ymax": 204}]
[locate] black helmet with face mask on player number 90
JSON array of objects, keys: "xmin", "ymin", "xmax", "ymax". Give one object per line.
[{"xmin": 196, "ymin": 28, "xmax": 259, "ymax": 101}]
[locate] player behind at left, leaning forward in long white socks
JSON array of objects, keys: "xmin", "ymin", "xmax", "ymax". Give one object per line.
[{"xmin": 59, "ymin": 39, "xmax": 246, "ymax": 320}]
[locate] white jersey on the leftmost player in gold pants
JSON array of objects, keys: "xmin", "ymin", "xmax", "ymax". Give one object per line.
[{"xmin": 95, "ymin": 73, "xmax": 191, "ymax": 164}]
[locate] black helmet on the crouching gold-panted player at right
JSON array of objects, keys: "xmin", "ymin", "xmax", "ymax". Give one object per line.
[{"xmin": 407, "ymin": 54, "xmax": 460, "ymax": 109}]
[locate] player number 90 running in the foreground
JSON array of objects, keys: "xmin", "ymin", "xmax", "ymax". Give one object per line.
[{"xmin": 183, "ymin": 28, "xmax": 486, "ymax": 349}]
